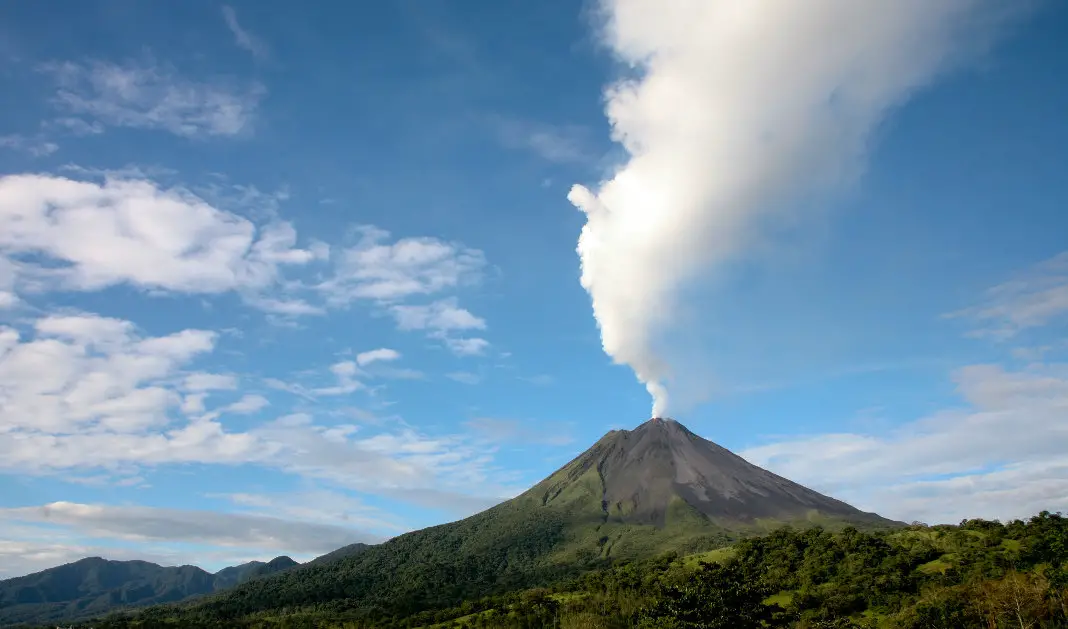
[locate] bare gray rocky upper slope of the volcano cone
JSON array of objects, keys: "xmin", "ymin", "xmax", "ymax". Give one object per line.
[{"xmin": 568, "ymin": 418, "xmax": 893, "ymax": 525}]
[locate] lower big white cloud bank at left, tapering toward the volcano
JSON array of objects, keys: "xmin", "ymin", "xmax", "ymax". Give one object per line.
[{"xmin": 0, "ymin": 313, "xmax": 514, "ymax": 512}]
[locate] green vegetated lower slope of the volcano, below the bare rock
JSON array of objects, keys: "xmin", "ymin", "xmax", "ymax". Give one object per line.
[{"xmin": 116, "ymin": 452, "xmax": 875, "ymax": 622}]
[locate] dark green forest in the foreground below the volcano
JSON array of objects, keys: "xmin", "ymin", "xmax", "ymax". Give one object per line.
[{"xmin": 62, "ymin": 512, "xmax": 1068, "ymax": 629}]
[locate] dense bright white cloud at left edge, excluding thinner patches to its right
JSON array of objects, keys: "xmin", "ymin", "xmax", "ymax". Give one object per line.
[{"xmin": 0, "ymin": 175, "xmax": 314, "ymax": 294}]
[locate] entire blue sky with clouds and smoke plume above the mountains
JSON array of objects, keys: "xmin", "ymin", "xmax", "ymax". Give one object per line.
[{"xmin": 0, "ymin": 0, "xmax": 1068, "ymax": 577}]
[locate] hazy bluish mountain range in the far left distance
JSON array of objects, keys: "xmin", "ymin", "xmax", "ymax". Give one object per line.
[{"xmin": 0, "ymin": 556, "xmax": 299, "ymax": 626}]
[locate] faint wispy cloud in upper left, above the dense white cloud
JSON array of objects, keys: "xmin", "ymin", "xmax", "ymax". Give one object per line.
[{"xmin": 43, "ymin": 61, "xmax": 265, "ymax": 138}]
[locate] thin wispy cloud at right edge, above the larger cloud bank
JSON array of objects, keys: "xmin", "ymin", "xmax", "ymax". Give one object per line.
[{"xmin": 948, "ymin": 252, "xmax": 1068, "ymax": 340}]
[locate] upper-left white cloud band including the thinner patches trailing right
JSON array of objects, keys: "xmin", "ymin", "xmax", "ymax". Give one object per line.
[{"xmin": 0, "ymin": 171, "xmax": 488, "ymax": 343}]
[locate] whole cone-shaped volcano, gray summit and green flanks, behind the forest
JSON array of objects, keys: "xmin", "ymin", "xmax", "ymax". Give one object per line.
[{"xmin": 166, "ymin": 419, "xmax": 899, "ymax": 623}]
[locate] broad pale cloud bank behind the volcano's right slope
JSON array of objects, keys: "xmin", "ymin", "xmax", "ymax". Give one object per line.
[{"xmin": 741, "ymin": 364, "xmax": 1068, "ymax": 522}]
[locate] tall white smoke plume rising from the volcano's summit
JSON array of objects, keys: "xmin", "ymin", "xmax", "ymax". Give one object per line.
[{"xmin": 567, "ymin": 0, "xmax": 1022, "ymax": 416}]
